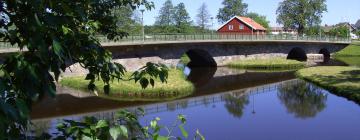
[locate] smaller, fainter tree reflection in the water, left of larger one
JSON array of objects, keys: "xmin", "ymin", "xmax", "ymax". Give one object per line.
[{"xmin": 224, "ymin": 91, "xmax": 249, "ymax": 118}]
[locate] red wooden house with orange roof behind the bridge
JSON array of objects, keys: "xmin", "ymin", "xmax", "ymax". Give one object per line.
[{"xmin": 217, "ymin": 16, "xmax": 266, "ymax": 35}]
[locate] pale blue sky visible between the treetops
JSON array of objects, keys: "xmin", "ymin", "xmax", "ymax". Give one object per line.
[{"xmin": 144, "ymin": 0, "xmax": 360, "ymax": 28}]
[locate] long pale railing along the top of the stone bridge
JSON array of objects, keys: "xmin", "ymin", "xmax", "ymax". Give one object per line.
[{"xmin": 98, "ymin": 34, "xmax": 351, "ymax": 46}]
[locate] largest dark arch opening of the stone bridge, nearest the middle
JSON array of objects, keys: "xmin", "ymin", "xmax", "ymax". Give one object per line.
[{"xmin": 186, "ymin": 49, "xmax": 217, "ymax": 67}]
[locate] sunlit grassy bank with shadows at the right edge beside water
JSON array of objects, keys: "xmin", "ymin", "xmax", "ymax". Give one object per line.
[{"xmin": 296, "ymin": 66, "xmax": 360, "ymax": 103}]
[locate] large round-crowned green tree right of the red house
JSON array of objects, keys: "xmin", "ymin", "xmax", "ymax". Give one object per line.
[{"xmin": 276, "ymin": 0, "xmax": 327, "ymax": 34}]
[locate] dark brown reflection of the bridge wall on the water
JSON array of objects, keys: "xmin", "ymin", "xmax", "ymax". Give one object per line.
[{"xmin": 31, "ymin": 67, "xmax": 295, "ymax": 119}]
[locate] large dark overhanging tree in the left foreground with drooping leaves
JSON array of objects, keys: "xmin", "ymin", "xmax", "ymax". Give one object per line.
[{"xmin": 0, "ymin": 0, "xmax": 175, "ymax": 139}]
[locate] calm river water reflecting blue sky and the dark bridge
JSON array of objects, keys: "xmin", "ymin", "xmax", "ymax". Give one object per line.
[{"xmin": 32, "ymin": 59, "xmax": 360, "ymax": 140}]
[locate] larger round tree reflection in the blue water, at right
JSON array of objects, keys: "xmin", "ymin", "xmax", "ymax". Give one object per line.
[{"xmin": 278, "ymin": 80, "xmax": 327, "ymax": 119}]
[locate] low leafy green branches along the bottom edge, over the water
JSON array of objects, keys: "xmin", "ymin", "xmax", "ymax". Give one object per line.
[{"xmin": 37, "ymin": 109, "xmax": 205, "ymax": 140}]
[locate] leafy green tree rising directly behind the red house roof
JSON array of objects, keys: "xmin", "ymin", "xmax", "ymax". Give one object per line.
[{"xmin": 216, "ymin": 0, "xmax": 248, "ymax": 23}]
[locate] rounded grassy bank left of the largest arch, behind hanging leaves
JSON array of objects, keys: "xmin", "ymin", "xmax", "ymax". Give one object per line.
[{"xmin": 60, "ymin": 69, "xmax": 194, "ymax": 101}]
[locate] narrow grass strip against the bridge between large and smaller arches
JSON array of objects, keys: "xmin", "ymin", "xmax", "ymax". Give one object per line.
[{"xmin": 228, "ymin": 58, "xmax": 305, "ymax": 69}]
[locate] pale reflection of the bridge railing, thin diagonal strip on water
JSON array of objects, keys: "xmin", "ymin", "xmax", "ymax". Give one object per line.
[{"xmin": 33, "ymin": 80, "xmax": 299, "ymax": 122}]
